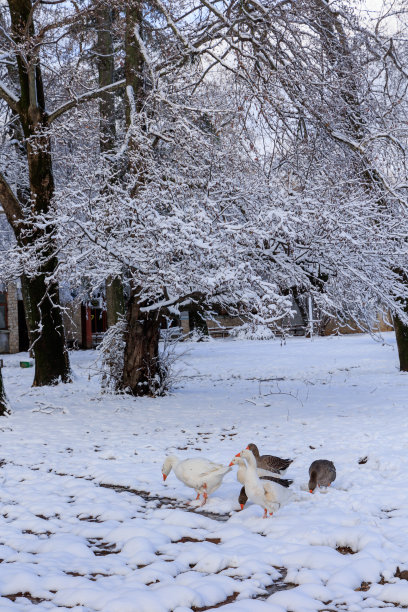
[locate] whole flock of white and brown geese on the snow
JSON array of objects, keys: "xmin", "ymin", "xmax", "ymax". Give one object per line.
[{"xmin": 162, "ymin": 444, "xmax": 336, "ymax": 518}]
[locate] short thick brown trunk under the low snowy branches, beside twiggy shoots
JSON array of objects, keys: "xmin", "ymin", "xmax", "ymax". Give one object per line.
[{"xmin": 123, "ymin": 297, "xmax": 161, "ymax": 396}]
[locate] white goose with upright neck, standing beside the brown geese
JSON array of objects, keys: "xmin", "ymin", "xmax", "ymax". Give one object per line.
[{"xmin": 239, "ymin": 449, "xmax": 289, "ymax": 518}]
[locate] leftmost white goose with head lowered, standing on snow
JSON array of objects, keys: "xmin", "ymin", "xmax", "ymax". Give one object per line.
[{"xmin": 162, "ymin": 455, "xmax": 231, "ymax": 506}]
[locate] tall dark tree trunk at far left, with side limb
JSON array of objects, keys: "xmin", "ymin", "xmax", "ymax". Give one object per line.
[{"xmin": 0, "ymin": 0, "xmax": 70, "ymax": 386}]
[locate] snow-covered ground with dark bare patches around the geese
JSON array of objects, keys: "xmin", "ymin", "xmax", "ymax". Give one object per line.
[{"xmin": 0, "ymin": 334, "xmax": 408, "ymax": 612}]
